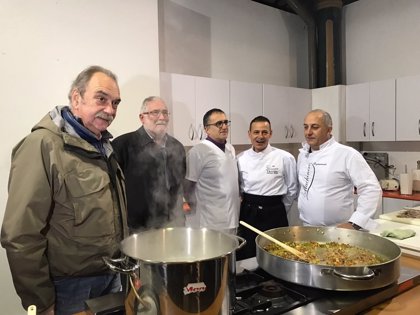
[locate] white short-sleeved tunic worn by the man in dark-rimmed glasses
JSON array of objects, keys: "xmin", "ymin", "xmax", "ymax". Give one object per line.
[{"xmin": 186, "ymin": 140, "xmax": 239, "ymax": 230}]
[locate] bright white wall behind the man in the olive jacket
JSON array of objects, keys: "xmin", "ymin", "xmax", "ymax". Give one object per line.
[{"xmin": 0, "ymin": 0, "xmax": 159, "ymax": 315}]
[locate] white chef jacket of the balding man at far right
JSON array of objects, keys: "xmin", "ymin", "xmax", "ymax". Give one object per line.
[{"xmin": 297, "ymin": 137, "xmax": 382, "ymax": 229}]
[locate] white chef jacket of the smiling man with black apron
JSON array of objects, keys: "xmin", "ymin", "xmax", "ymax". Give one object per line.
[{"xmin": 237, "ymin": 144, "xmax": 298, "ymax": 212}]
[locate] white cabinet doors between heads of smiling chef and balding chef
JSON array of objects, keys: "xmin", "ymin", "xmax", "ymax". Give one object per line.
[{"xmin": 263, "ymin": 84, "xmax": 312, "ymax": 143}]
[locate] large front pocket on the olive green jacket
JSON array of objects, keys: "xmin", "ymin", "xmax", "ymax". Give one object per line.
[{"xmin": 65, "ymin": 168, "xmax": 115, "ymax": 237}]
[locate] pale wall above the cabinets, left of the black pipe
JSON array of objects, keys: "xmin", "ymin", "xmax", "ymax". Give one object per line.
[{"xmin": 159, "ymin": 0, "xmax": 309, "ymax": 87}]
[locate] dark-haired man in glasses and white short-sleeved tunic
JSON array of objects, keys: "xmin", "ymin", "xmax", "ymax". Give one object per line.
[{"xmin": 186, "ymin": 108, "xmax": 239, "ymax": 234}]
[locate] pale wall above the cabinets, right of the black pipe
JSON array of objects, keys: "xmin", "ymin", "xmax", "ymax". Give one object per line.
[{"xmin": 343, "ymin": 0, "xmax": 420, "ymax": 84}]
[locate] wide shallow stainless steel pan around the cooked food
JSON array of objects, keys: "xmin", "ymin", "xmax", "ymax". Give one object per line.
[{"xmin": 256, "ymin": 226, "xmax": 401, "ymax": 291}]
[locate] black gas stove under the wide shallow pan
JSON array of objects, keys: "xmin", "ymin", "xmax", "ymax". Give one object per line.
[{"xmin": 232, "ymin": 260, "xmax": 420, "ymax": 315}]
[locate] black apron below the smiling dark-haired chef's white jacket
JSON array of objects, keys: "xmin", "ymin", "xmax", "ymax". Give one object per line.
[{"xmin": 236, "ymin": 193, "xmax": 289, "ymax": 260}]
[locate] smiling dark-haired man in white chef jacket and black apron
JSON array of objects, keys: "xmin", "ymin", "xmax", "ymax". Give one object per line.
[{"xmin": 237, "ymin": 116, "xmax": 298, "ymax": 260}]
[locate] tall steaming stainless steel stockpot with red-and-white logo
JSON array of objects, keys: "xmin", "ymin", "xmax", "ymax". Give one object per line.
[{"xmin": 104, "ymin": 227, "xmax": 245, "ymax": 315}]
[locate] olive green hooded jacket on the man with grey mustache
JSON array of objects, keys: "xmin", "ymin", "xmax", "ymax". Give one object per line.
[{"xmin": 1, "ymin": 108, "xmax": 128, "ymax": 311}]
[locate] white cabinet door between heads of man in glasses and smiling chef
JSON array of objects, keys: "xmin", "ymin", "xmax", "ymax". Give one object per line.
[{"xmin": 230, "ymin": 81, "xmax": 262, "ymax": 144}]
